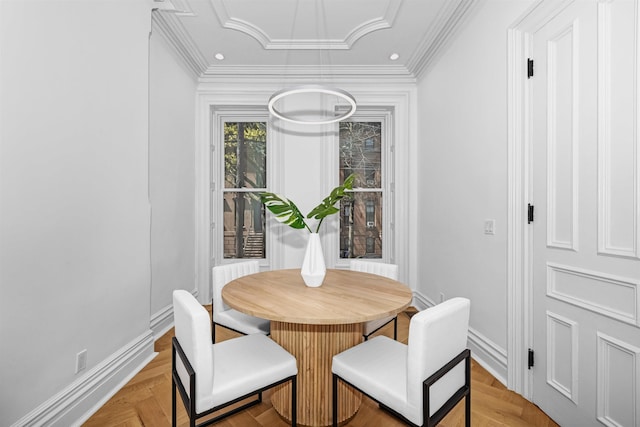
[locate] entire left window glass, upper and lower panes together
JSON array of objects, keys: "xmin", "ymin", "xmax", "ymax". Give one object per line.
[{"xmin": 222, "ymin": 120, "xmax": 267, "ymax": 258}]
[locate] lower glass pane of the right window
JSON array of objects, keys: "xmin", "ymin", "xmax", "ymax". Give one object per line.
[{"xmin": 340, "ymin": 192, "xmax": 382, "ymax": 258}]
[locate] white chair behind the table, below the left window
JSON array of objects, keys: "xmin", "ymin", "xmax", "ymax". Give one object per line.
[{"xmin": 211, "ymin": 260, "xmax": 270, "ymax": 343}]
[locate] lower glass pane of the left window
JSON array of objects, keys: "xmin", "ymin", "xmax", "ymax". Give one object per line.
[{"xmin": 223, "ymin": 192, "xmax": 266, "ymax": 258}]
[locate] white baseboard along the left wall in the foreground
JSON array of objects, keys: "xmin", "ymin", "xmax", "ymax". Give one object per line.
[{"xmin": 12, "ymin": 330, "xmax": 157, "ymax": 427}]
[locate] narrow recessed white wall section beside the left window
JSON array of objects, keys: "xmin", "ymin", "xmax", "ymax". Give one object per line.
[{"xmin": 149, "ymin": 21, "xmax": 196, "ymax": 334}]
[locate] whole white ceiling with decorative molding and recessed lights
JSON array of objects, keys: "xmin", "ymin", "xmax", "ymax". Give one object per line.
[{"xmin": 153, "ymin": 0, "xmax": 480, "ymax": 81}]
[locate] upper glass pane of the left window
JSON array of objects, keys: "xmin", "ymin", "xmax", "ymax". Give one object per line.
[{"xmin": 224, "ymin": 122, "xmax": 267, "ymax": 188}]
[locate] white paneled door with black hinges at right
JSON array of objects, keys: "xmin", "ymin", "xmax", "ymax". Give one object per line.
[{"xmin": 529, "ymin": 0, "xmax": 640, "ymax": 427}]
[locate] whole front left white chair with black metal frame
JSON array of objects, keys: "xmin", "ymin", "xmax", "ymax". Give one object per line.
[{"xmin": 171, "ymin": 290, "xmax": 298, "ymax": 427}]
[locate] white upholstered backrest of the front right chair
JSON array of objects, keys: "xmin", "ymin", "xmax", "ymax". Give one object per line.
[{"xmin": 407, "ymin": 298, "xmax": 471, "ymax": 418}]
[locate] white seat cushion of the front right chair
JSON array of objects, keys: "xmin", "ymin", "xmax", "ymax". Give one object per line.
[{"xmin": 331, "ymin": 336, "xmax": 407, "ymax": 415}]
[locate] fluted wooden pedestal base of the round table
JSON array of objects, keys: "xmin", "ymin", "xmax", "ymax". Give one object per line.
[{"xmin": 271, "ymin": 321, "xmax": 362, "ymax": 426}]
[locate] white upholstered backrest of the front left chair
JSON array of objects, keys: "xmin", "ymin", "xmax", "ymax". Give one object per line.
[{"xmin": 173, "ymin": 290, "xmax": 213, "ymax": 407}]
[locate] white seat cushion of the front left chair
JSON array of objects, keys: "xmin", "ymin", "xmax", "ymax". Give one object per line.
[{"xmin": 208, "ymin": 334, "xmax": 298, "ymax": 411}]
